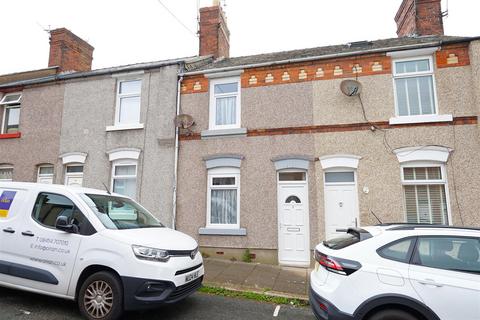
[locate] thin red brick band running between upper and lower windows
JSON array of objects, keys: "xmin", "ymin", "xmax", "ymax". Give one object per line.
[{"xmin": 180, "ymin": 116, "xmax": 478, "ymax": 141}]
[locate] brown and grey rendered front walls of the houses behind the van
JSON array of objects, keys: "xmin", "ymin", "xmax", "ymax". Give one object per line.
[{"xmin": 0, "ymin": 55, "xmax": 204, "ymax": 226}]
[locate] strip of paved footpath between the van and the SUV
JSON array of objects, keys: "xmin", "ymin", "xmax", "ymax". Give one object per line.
[{"xmin": 204, "ymin": 258, "xmax": 310, "ymax": 300}]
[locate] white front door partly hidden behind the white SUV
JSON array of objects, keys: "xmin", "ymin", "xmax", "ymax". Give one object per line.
[{"xmin": 324, "ymin": 171, "xmax": 359, "ymax": 239}]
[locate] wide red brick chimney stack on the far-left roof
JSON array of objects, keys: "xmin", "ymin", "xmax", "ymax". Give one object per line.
[{"xmin": 48, "ymin": 28, "xmax": 94, "ymax": 72}]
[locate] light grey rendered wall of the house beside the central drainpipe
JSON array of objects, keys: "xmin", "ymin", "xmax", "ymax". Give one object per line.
[{"xmin": 59, "ymin": 63, "xmax": 180, "ymax": 225}]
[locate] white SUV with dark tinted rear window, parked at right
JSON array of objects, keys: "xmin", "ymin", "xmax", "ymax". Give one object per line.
[{"xmin": 310, "ymin": 224, "xmax": 480, "ymax": 320}]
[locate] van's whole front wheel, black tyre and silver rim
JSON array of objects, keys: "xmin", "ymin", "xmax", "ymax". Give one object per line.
[{"xmin": 78, "ymin": 271, "xmax": 123, "ymax": 320}]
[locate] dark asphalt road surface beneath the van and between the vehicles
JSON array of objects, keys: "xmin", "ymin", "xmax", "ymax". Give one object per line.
[{"xmin": 0, "ymin": 287, "xmax": 315, "ymax": 320}]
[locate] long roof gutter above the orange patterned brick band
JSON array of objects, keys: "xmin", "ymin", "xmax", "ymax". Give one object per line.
[{"xmin": 180, "ymin": 37, "xmax": 480, "ymax": 76}]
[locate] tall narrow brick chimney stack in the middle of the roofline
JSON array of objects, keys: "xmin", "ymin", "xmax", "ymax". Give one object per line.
[{"xmin": 199, "ymin": 0, "xmax": 230, "ymax": 58}]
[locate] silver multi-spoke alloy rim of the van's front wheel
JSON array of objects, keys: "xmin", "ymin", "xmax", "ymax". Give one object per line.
[{"xmin": 83, "ymin": 281, "xmax": 113, "ymax": 319}]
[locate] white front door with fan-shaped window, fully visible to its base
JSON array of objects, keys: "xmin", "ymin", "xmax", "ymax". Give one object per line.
[{"xmin": 278, "ymin": 172, "xmax": 310, "ymax": 266}]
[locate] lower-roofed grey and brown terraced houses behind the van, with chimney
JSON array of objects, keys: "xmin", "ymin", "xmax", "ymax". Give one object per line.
[{"xmin": 0, "ymin": 28, "xmax": 206, "ymax": 225}]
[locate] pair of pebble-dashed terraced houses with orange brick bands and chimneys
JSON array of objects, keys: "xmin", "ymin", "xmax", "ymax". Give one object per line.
[{"xmin": 176, "ymin": 0, "xmax": 480, "ymax": 266}]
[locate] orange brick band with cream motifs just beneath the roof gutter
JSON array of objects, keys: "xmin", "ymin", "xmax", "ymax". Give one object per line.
[{"xmin": 181, "ymin": 43, "xmax": 470, "ymax": 94}]
